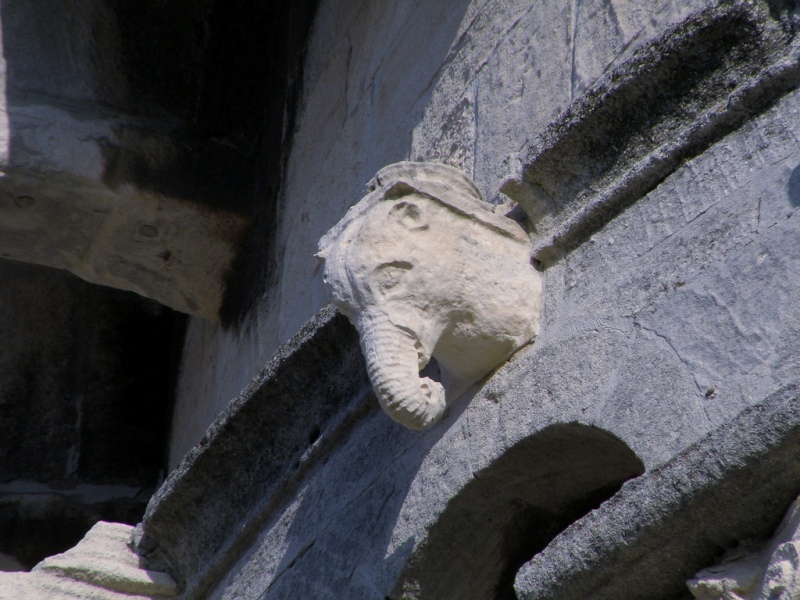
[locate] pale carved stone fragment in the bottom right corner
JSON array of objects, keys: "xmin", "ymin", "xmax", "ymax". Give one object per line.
[{"xmin": 687, "ymin": 498, "xmax": 800, "ymax": 600}]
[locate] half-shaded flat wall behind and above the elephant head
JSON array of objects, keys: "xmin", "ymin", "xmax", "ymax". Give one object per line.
[{"xmin": 170, "ymin": 0, "xmax": 708, "ymax": 466}]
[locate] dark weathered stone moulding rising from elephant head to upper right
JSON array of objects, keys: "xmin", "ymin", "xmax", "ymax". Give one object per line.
[{"xmin": 501, "ymin": 0, "xmax": 800, "ymax": 264}]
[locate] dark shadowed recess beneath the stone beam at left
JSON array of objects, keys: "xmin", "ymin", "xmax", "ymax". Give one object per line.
[{"xmin": 0, "ymin": 261, "xmax": 186, "ymax": 568}]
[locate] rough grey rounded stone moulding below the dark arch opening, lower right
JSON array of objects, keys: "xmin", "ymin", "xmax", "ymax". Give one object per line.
[{"xmin": 515, "ymin": 383, "xmax": 800, "ymax": 600}]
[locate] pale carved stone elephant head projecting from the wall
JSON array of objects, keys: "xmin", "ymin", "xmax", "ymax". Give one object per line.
[{"xmin": 317, "ymin": 162, "xmax": 541, "ymax": 429}]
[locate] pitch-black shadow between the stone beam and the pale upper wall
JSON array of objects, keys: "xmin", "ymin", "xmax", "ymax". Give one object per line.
[{"xmin": 105, "ymin": 0, "xmax": 317, "ymax": 326}]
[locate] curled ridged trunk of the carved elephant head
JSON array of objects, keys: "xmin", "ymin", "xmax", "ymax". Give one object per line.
[{"xmin": 359, "ymin": 317, "xmax": 445, "ymax": 430}]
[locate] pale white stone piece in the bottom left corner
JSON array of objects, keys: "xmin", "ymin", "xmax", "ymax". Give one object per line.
[{"xmin": 0, "ymin": 521, "xmax": 177, "ymax": 600}]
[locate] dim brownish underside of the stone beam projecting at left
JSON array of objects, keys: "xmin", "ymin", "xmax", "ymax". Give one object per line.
[{"xmin": 0, "ymin": 166, "xmax": 249, "ymax": 319}]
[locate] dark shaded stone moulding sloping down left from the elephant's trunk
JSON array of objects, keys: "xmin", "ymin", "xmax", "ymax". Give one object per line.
[{"xmin": 137, "ymin": 308, "xmax": 372, "ymax": 598}]
